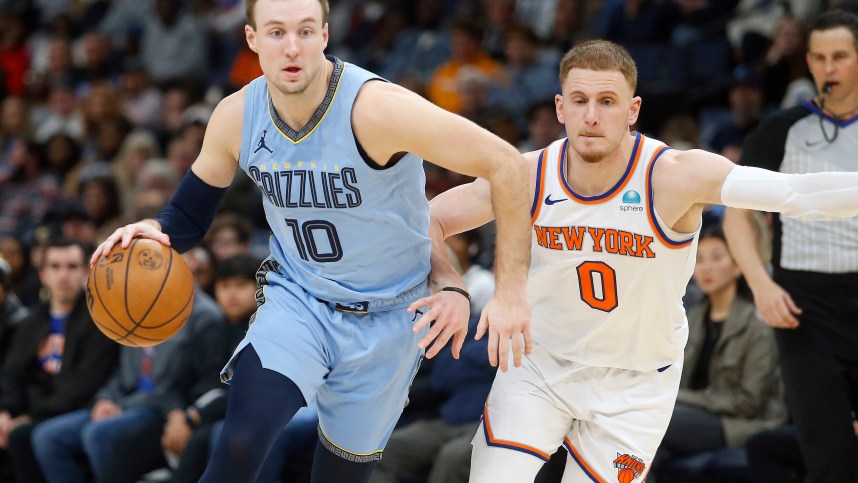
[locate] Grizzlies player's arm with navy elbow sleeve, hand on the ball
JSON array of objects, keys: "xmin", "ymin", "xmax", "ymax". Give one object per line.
[{"xmin": 89, "ymin": 90, "xmax": 244, "ymax": 266}]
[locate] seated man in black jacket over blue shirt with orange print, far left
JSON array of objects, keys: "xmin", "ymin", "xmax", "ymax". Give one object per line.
[{"xmin": 0, "ymin": 240, "xmax": 119, "ymax": 482}]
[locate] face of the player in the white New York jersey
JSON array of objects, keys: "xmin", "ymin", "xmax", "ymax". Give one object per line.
[{"xmin": 554, "ymin": 69, "xmax": 641, "ymax": 163}]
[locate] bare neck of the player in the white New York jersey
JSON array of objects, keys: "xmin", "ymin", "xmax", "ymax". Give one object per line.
[{"xmin": 566, "ymin": 137, "xmax": 634, "ymax": 196}]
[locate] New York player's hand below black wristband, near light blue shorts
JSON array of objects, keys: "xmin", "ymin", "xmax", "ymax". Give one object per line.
[{"xmin": 408, "ymin": 291, "xmax": 471, "ymax": 359}]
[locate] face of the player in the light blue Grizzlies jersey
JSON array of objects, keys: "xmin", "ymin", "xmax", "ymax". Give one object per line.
[{"xmin": 244, "ymin": 0, "xmax": 328, "ymax": 94}]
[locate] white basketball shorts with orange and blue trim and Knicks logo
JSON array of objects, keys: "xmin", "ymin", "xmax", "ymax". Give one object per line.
[{"xmin": 471, "ymin": 344, "xmax": 682, "ymax": 483}]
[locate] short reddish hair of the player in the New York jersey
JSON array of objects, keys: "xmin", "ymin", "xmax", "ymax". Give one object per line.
[{"xmin": 560, "ymin": 40, "xmax": 638, "ymax": 92}]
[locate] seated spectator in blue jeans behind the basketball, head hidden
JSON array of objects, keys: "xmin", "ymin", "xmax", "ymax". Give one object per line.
[{"xmin": 32, "ymin": 289, "xmax": 226, "ymax": 483}]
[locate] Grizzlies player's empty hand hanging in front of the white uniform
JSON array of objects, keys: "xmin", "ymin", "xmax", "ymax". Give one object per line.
[{"xmin": 475, "ymin": 292, "xmax": 533, "ymax": 372}]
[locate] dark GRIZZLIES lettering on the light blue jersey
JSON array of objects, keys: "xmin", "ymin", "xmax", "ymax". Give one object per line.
[{"xmin": 247, "ymin": 161, "xmax": 361, "ymax": 208}]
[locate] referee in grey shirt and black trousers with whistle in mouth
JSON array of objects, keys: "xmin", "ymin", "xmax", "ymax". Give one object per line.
[{"xmin": 724, "ymin": 11, "xmax": 858, "ymax": 483}]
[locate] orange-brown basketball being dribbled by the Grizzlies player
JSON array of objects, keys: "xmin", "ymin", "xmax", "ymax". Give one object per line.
[{"xmin": 86, "ymin": 238, "xmax": 194, "ymax": 347}]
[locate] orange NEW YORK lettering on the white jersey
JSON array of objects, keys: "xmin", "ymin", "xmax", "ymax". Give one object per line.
[{"xmin": 533, "ymin": 225, "xmax": 655, "ymax": 258}]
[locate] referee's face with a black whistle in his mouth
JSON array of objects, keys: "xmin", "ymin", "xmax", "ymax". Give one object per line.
[{"xmin": 807, "ymin": 27, "xmax": 858, "ymax": 102}]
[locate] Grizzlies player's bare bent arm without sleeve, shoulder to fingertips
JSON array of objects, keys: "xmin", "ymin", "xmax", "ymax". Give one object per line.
[{"xmin": 352, "ymin": 82, "xmax": 530, "ymax": 370}]
